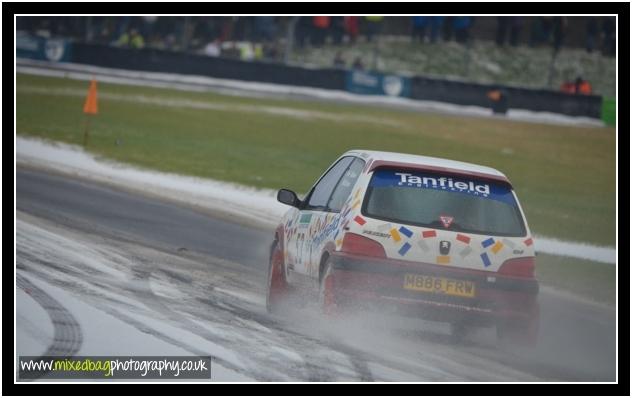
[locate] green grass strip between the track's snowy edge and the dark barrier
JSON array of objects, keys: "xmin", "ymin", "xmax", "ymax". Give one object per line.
[{"xmin": 16, "ymin": 74, "xmax": 615, "ymax": 246}]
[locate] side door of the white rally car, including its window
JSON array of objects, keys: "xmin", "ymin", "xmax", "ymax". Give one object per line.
[{"xmin": 287, "ymin": 156, "xmax": 354, "ymax": 275}]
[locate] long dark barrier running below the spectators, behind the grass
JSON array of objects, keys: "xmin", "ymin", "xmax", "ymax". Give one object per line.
[{"xmin": 16, "ymin": 41, "xmax": 602, "ymax": 119}]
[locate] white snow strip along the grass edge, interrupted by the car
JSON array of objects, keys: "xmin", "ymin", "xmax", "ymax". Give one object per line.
[{"xmin": 16, "ymin": 136, "xmax": 616, "ymax": 264}]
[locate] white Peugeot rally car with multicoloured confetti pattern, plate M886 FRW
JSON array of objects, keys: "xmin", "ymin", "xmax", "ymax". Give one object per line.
[{"xmin": 267, "ymin": 150, "xmax": 539, "ymax": 343}]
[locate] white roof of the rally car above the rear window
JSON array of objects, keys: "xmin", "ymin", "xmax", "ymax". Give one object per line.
[{"xmin": 345, "ymin": 149, "xmax": 510, "ymax": 184}]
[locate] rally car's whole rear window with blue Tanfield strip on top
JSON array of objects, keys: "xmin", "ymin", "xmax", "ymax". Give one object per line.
[{"xmin": 362, "ymin": 169, "xmax": 526, "ymax": 236}]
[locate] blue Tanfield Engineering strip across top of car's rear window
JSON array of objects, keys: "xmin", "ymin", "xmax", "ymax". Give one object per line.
[{"xmin": 370, "ymin": 169, "xmax": 516, "ymax": 205}]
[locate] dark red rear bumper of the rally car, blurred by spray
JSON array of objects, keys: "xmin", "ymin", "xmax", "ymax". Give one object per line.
[{"xmin": 330, "ymin": 253, "xmax": 539, "ymax": 324}]
